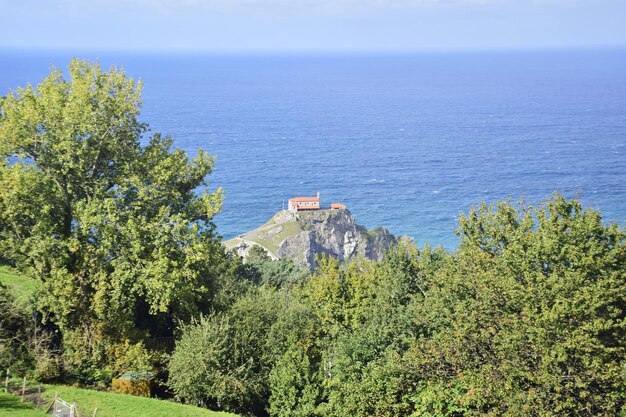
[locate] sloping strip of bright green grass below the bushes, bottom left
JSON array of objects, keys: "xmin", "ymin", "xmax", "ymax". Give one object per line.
[{"xmin": 39, "ymin": 385, "xmax": 237, "ymax": 417}]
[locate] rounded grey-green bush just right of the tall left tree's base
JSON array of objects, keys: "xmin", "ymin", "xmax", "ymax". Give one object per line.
[{"xmin": 169, "ymin": 287, "xmax": 320, "ymax": 415}]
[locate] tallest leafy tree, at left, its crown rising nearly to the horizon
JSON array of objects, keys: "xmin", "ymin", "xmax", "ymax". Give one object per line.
[{"xmin": 0, "ymin": 59, "xmax": 224, "ymax": 380}]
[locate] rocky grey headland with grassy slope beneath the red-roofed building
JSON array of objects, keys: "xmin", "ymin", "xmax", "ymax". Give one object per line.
[{"xmin": 225, "ymin": 210, "xmax": 399, "ymax": 268}]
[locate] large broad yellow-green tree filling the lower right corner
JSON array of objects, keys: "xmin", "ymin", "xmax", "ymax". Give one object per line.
[{"xmin": 405, "ymin": 195, "xmax": 626, "ymax": 416}]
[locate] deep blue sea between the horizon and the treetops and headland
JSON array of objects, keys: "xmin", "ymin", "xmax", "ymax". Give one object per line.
[{"xmin": 0, "ymin": 50, "xmax": 626, "ymax": 248}]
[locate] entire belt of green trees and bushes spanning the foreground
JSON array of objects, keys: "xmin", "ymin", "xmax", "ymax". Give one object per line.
[{"xmin": 0, "ymin": 60, "xmax": 626, "ymax": 417}]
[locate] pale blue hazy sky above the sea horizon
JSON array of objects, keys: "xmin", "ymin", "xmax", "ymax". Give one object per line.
[{"xmin": 0, "ymin": 0, "xmax": 626, "ymax": 53}]
